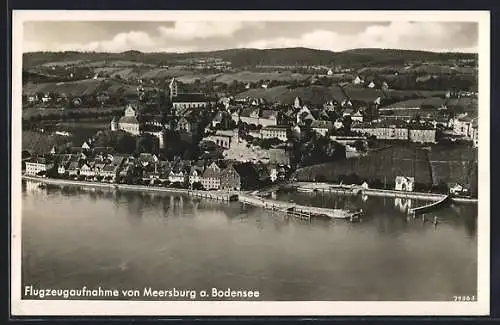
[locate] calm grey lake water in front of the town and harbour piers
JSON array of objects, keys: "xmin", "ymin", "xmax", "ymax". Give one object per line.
[{"xmin": 22, "ymin": 182, "xmax": 477, "ymax": 301}]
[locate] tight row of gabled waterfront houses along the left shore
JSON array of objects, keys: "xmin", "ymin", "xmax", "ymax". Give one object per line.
[{"xmin": 25, "ymin": 144, "xmax": 287, "ymax": 191}]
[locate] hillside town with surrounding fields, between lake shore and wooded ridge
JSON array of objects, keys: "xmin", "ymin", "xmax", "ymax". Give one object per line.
[{"xmin": 23, "ymin": 47, "xmax": 479, "ymax": 196}]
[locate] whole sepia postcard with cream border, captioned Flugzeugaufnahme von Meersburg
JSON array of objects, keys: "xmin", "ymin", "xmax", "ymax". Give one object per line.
[{"xmin": 11, "ymin": 11, "xmax": 490, "ymax": 316}]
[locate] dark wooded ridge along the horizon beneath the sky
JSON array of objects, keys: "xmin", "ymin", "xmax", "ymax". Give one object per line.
[{"xmin": 23, "ymin": 47, "xmax": 477, "ymax": 69}]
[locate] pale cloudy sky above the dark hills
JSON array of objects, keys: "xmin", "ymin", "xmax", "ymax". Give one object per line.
[{"xmin": 23, "ymin": 21, "xmax": 478, "ymax": 52}]
